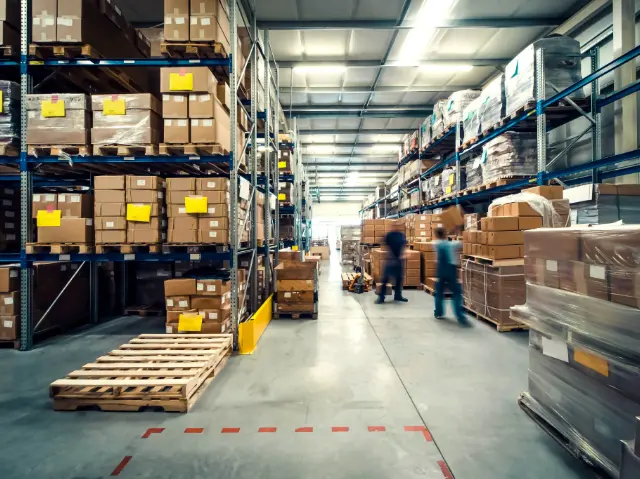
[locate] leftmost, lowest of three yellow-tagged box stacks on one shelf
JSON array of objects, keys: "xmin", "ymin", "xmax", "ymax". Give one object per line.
[{"xmin": 31, "ymin": 193, "xmax": 94, "ymax": 246}]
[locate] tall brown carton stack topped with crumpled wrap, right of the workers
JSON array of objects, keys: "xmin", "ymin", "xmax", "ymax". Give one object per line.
[{"xmin": 462, "ymin": 186, "xmax": 569, "ymax": 331}]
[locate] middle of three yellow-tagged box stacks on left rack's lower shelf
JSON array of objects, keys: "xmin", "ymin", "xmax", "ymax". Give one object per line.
[{"xmin": 94, "ymin": 175, "xmax": 166, "ymax": 245}]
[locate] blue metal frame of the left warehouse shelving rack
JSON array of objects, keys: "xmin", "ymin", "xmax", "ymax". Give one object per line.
[{"xmin": 6, "ymin": 0, "xmax": 279, "ymax": 350}]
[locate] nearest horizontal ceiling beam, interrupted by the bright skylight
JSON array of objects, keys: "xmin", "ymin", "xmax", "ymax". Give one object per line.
[{"xmin": 258, "ymin": 17, "xmax": 564, "ymax": 30}]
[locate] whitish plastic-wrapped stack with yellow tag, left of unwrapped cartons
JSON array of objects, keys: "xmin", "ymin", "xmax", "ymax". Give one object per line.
[{"xmin": 91, "ymin": 93, "xmax": 162, "ymax": 155}]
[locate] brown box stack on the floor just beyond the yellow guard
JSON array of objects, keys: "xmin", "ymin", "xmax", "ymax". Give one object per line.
[{"xmin": 275, "ymin": 251, "xmax": 318, "ymax": 319}]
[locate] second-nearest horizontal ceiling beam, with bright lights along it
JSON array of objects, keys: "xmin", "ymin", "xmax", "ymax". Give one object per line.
[{"xmin": 278, "ymin": 58, "xmax": 512, "ymax": 69}]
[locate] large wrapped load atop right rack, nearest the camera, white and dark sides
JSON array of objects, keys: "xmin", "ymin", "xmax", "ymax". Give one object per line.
[{"xmin": 505, "ymin": 36, "xmax": 583, "ymax": 115}]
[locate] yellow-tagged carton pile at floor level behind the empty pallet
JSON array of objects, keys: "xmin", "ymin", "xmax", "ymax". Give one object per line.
[{"xmin": 164, "ymin": 278, "xmax": 231, "ymax": 334}]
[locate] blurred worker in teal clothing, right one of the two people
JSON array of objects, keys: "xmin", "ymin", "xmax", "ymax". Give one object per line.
[{"xmin": 434, "ymin": 228, "xmax": 467, "ymax": 324}]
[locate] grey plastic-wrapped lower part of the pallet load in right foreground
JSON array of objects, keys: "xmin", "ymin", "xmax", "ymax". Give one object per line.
[{"xmin": 523, "ymin": 345, "xmax": 640, "ymax": 477}]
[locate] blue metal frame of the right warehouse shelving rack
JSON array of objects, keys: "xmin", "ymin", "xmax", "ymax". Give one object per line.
[{"xmin": 361, "ymin": 46, "xmax": 640, "ymax": 217}]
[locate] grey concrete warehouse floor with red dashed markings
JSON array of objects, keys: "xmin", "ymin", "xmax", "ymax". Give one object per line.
[{"xmin": 0, "ymin": 262, "xmax": 592, "ymax": 479}]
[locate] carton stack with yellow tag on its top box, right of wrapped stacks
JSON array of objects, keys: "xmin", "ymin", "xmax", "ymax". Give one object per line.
[{"xmin": 160, "ymin": 67, "xmax": 231, "ymax": 151}]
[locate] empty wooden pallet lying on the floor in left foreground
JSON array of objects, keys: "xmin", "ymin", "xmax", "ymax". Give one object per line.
[{"xmin": 49, "ymin": 334, "xmax": 233, "ymax": 412}]
